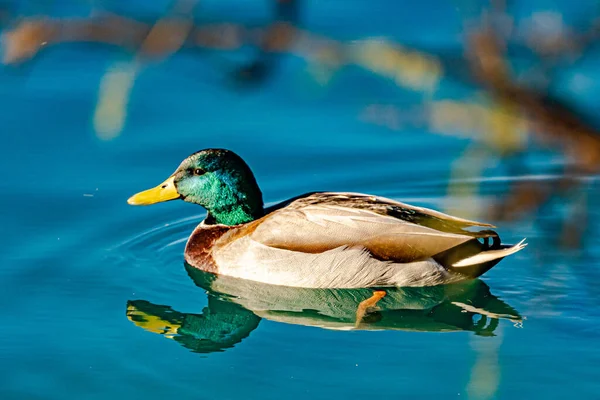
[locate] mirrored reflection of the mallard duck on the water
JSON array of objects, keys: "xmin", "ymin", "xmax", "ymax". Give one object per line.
[{"xmin": 127, "ymin": 265, "xmax": 522, "ymax": 353}]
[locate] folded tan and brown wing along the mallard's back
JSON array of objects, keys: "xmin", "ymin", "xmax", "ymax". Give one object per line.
[{"xmin": 223, "ymin": 193, "xmax": 497, "ymax": 262}]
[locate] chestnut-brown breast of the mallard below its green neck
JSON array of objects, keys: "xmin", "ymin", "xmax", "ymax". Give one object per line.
[{"xmin": 184, "ymin": 225, "xmax": 231, "ymax": 274}]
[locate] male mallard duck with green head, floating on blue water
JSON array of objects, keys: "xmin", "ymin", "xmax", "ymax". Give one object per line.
[{"xmin": 128, "ymin": 149, "xmax": 525, "ymax": 288}]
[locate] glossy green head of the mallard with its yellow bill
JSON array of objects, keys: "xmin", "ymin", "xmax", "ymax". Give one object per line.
[{"xmin": 127, "ymin": 149, "xmax": 264, "ymax": 225}]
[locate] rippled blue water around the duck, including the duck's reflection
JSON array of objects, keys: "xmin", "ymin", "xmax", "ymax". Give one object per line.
[{"xmin": 0, "ymin": 1, "xmax": 600, "ymax": 399}]
